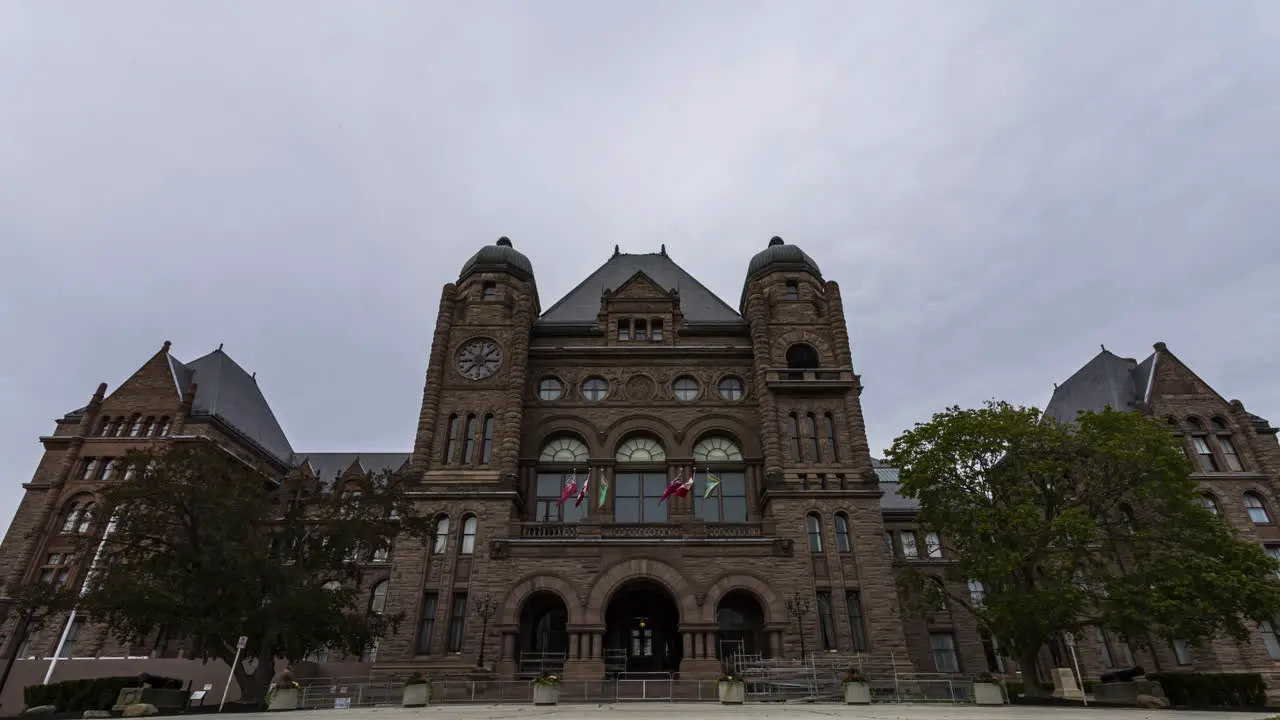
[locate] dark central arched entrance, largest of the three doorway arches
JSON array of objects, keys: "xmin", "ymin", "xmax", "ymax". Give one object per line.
[{"xmin": 604, "ymin": 580, "xmax": 685, "ymax": 676}]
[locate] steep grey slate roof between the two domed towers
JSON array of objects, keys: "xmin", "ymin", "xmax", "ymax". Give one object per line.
[{"xmin": 538, "ymin": 251, "xmax": 742, "ymax": 327}]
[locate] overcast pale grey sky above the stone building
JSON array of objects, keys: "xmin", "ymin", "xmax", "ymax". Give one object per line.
[{"xmin": 0, "ymin": 0, "xmax": 1280, "ymax": 523}]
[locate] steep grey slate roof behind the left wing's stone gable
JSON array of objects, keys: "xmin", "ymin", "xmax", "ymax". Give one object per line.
[{"xmin": 169, "ymin": 347, "xmax": 293, "ymax": 464}]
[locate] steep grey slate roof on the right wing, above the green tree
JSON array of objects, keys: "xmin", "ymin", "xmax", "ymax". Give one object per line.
[{"xmin": 1044, "ymin": 350, "xmax": 1156, "ymax": 423}]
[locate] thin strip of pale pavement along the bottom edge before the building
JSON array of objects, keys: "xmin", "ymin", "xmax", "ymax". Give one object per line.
[{"xmin": 237, "ymin": 702, "xmax": 1276, "ymax": 720}]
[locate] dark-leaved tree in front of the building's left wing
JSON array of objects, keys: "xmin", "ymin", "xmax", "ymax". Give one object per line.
[{"xmin": 68, "ymin": 442, "xmax": 429, "ymax": 702}]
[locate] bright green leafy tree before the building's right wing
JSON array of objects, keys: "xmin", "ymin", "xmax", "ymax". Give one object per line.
[{"xmin": 886, "ymin": 402, "xmax": 1280, "ymax": 693}]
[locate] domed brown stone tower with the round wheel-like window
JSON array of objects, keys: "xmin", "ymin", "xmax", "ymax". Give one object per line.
[{"xmin": 412, "ymin": 237, "xmax": 540, "ymax": 484}]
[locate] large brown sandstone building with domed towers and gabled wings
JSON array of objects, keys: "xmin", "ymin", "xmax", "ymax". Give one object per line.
[{"xmin": 0, "ymin": 238, "xmax": 1280, "ymax": 698}]
